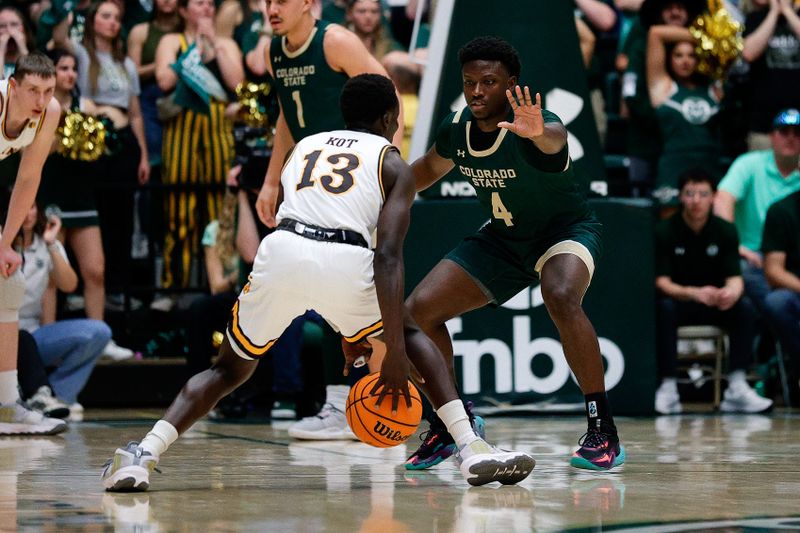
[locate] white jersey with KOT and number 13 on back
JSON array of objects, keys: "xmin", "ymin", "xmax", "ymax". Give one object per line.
[{"xmin": 276, "ymin": 130, "xmax": 395, "ymax": 248}]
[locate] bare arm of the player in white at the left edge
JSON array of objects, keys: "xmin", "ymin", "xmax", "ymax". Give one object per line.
[{"xmin": 0, "ymin": 99, "xmax": 61, "ymax": 278}]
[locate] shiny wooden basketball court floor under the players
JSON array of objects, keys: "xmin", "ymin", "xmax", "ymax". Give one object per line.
[{"xmin": 0, "ymin": 410, "xmax": 800, "ymax": 533}]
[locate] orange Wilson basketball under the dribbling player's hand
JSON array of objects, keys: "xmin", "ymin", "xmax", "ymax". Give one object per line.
[{"xmin": 346, "ymin": 372, "xmax": 422, "ymax": 448}]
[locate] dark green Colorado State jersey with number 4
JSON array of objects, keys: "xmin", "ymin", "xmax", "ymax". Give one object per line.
[{"xmin": 435, "ymin": 107, "xmax": 591, "ymax": 240}]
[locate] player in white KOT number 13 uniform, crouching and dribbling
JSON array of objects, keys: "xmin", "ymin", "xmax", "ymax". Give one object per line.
[{"xmin": 103, "ymin": 74, "xmax": 535, "ymax": 491}]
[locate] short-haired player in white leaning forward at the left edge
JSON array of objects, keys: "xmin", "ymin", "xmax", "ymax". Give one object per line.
[{"xmin": 0, "ymin": 53, "xmax": 67, "ymax": 436}]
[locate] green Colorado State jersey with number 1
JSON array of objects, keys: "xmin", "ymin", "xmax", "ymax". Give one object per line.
[{"xmin": 269, "ymin": 20, "xmax": 347, "ymax": 142}]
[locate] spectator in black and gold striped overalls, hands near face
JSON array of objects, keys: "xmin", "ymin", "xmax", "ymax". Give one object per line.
[{"xmin": 156, "ymin": 0, "xmax": 244, "ymax": 288}]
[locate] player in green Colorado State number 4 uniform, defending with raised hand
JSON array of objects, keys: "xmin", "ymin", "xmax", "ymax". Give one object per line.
[{"xmin": 406, "ymin": 37, "xmax": 625, "ymax": 470}]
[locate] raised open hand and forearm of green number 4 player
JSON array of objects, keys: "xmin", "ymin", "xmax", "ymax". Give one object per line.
[{"xmin": 497, "ymin": 85, "xmax": 567, "ymax": 154}]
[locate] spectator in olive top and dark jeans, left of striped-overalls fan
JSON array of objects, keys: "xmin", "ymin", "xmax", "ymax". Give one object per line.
[{"xmin": 128, "ymin": 0, "xmax": 182, "ymax": 166}]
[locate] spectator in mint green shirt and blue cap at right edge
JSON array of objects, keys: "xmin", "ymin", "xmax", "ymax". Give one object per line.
[{"xmin": 714, "ymin": 109, "xmax": 800, "ymax": 311}]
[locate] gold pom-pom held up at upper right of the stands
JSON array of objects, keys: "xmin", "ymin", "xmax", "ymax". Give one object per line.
[{"xmin": 689, "ymin": 0, "xmax": 743, "ymax": 80}]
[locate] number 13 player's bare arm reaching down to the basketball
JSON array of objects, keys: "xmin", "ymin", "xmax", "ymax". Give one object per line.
[{"xmin": 374, "ymin": 150, "xmax": 414, "ymax": 412}]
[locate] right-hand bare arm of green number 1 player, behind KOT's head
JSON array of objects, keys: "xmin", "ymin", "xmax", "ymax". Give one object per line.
[{"xmin": 322, "ymin": 24, "xmax": 405, "ymax": 148}]
